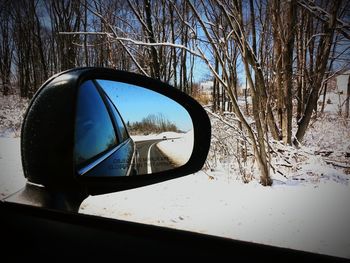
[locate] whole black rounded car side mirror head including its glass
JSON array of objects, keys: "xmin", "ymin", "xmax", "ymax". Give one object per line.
[{"xmin": 21, "ymin": 68, "xmax": 211, "ymax": 198}]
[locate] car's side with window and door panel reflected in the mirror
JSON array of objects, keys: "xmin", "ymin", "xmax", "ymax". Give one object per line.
[{"xmin": 74, "ymin": 80, "xmax": 135, "ymax": 176}]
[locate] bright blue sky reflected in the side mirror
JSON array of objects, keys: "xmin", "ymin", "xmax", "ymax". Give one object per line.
[{"xmin": 97, "ymin": 80, "xmax": 193, "ymax": 131}]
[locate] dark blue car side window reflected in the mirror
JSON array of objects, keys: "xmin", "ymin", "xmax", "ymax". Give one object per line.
[{"xmin": 74, "ymin": 81, "xmax": 117, "ymax": 165}]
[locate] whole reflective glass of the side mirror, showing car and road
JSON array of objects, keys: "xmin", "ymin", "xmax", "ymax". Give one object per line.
[{"xmin": 74, "ymin": 79, "xmax": 193, "ymax": 177}]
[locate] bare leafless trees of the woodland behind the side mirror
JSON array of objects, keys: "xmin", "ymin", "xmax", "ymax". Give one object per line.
[{"xmin": 0, "ymin": 0, "xmax": 350, "ymax": 185}]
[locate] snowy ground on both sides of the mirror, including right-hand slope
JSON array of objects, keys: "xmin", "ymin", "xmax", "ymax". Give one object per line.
[{"xmin": 0, "ymin": 95, "xmax": 350, "ymax": 258}]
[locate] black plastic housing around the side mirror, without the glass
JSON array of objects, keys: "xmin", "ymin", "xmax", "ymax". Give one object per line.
[{"xmin": 21, "ymin": 68, "xmax": 211, "ymax": 196}]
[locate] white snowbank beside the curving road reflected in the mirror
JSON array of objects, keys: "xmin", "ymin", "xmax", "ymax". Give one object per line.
[{"xmin": 156, "ymin": 130, "xmax": 193, "ymax": 166}]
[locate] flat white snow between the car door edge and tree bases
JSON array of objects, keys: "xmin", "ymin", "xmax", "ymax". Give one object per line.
[{"xmin": 80, "ymin": 172, "xmax": 350, "ymax": 258}]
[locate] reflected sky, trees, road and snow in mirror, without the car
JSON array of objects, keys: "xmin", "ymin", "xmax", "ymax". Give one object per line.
[{"xmin": 97, "ymin": 80, "xmax": 193, "ymax": 174}]
